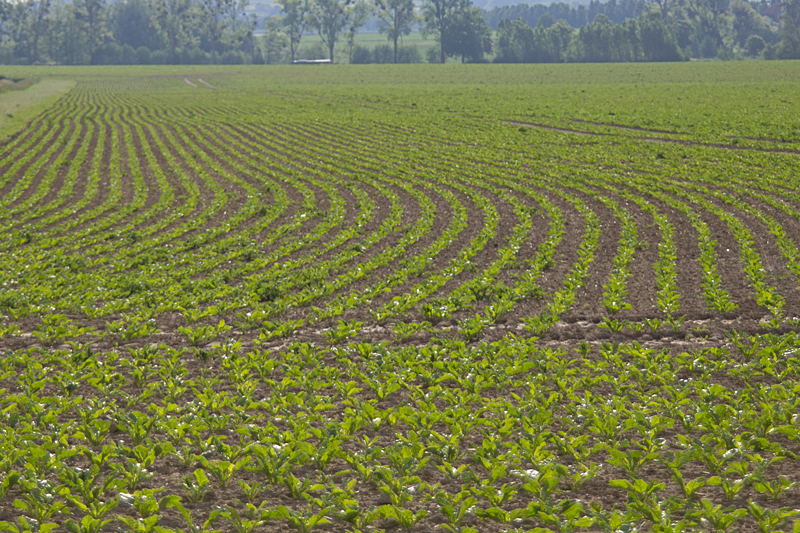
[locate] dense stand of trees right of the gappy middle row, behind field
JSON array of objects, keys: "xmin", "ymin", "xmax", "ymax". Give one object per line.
[{"xmin": 486, "ymin": 0, "xmax": 800, "ymax": 63}]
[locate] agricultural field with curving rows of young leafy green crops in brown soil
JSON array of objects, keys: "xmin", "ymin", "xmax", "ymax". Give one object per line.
[{"xmin": 0, "ymin": 61, "xmax": 800, "ymax": 533}]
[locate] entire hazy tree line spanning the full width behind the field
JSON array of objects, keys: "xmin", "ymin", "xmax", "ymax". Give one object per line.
[{"xmin": 0, "ymin": 0, "xmax": 800, "ymax": 65}]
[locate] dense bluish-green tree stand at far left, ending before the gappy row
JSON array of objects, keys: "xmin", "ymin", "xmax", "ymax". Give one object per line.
[{"xmin": 0, "ymin": 0, "xmax": 261, "ymax": 65}]
